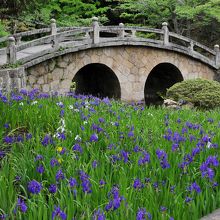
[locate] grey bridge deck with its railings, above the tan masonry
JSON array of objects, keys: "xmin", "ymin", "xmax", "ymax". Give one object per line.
[{"xmin": 0, "ymin": 21, "xmax": 220, "ymax": 69}]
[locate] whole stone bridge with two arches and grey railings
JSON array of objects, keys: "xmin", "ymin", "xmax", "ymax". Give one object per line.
[{"xmin": 0, "ymin": 18, "xmax": 220, "ymax": 103}]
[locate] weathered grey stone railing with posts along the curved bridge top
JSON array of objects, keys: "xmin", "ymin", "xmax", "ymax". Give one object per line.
[{"xmin": 0, "ymin": 17, "xmax": 220, "ymax": 69}]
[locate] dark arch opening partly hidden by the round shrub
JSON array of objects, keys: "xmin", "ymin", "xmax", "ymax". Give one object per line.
[{"xmin": 144, "ymin": 63, "xmax": 183, "ymax": 105}]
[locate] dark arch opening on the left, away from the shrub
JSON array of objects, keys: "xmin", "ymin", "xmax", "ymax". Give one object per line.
[{"xmin": 73, "ymin": 63, "xmax": 121, "ymax": 99}]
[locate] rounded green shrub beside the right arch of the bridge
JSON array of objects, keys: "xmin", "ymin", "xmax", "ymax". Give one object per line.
[{"xmin": 166, "ymin": 79, "xmax": 220, "ymax": 109}]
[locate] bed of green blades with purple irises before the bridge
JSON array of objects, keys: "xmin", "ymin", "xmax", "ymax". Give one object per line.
[{"xmin": 0, "ymin": 90, "xmax": 220, "ymax": 220}]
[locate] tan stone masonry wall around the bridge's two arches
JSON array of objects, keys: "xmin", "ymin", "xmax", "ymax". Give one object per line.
[{"xmin": 26, "ymin": 46, "xmax": 215, "ymax": 101}]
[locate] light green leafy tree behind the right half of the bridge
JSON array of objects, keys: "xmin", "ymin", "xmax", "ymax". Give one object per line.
[{"xmin": 120, "ymin": 0, "xmax": 220, "ymax": 43}]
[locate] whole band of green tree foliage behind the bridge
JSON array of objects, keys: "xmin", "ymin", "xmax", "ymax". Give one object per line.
[{"xmin": 0, "ymin": 0, "xmax": 220, "ymax": 47}]
